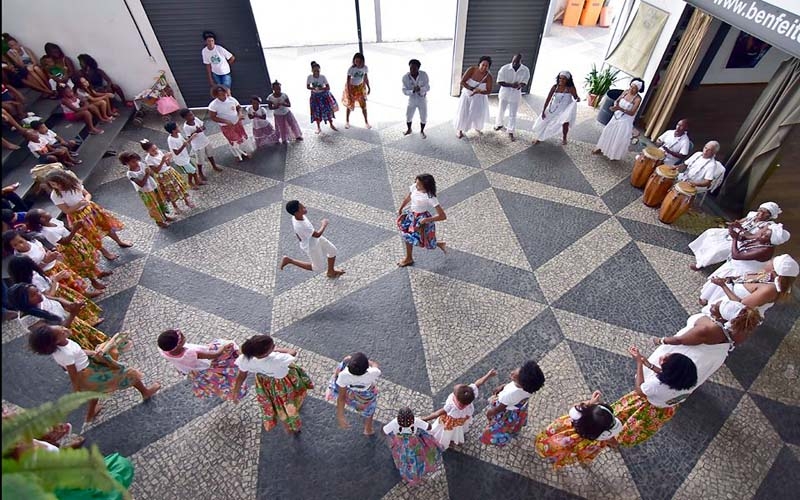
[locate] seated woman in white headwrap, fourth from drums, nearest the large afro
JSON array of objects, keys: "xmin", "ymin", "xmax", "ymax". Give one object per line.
[{"xmin": 653, "ymin": 298, "xmax": 761, "ymax": 351}]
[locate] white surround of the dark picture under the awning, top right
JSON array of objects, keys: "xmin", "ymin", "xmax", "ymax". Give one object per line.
[{"xmin": 701, "ymin": 28, "xmax": 791, "ymax": 85}]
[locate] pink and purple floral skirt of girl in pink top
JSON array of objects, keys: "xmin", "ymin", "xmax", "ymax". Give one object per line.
[{"xmin": 186, "ymin": 339, "xmax": 247, "ymax": 399}]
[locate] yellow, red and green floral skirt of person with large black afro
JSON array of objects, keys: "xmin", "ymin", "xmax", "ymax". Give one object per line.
[{"xmin": 611, "ymin": 391, "xmax": 678, "ymax": 446}]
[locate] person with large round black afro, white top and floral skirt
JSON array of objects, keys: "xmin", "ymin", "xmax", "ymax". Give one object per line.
[{"xmin": 611, "ymin": 346, "xmax": 696, "ymax": 446}]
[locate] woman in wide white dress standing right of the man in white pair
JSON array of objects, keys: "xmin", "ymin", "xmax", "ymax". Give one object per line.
[{"xmin": 533, "ymin": 71, "xmax": 581, "ymax": 144}]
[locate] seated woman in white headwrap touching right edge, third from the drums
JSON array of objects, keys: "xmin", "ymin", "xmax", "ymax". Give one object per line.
[{"xmin": 706, "ymin": 254, "xmax": 800, "ymax": 316}]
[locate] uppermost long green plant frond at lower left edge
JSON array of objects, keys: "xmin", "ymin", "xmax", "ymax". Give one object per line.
[{"xmin": 3, "ymin": 392, "xmax": 105, "ymax": 455}]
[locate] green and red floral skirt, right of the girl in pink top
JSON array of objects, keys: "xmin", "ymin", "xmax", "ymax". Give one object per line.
[{"xmin": 256, "ymin": 365, "xmax": 314, "ymax": 432}]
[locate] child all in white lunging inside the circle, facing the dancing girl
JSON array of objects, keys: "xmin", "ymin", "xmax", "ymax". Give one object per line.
[{"xmin": 281, "ymin": 200, "xmax": 344, "ymax": 278}]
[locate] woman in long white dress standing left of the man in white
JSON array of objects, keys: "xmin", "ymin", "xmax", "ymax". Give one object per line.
[{"xmin": 453, "ymin": 56, "xmax": 494, "ymax": 139}]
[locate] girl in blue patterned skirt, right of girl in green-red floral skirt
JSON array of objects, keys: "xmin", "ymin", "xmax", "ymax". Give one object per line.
[{"xmin": 325, "ymin": 352, "xmax": 381, "ymax": 436}]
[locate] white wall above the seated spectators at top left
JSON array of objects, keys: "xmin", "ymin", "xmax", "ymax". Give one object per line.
[{"xmin": 2, "ymin": 0, "xmax": 183, "ymax": 102}]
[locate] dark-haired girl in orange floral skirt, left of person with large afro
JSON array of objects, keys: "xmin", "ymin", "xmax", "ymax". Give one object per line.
[{"xmin": 535, "ymin": 391, "xmax": 622, "ymax": 469}]
